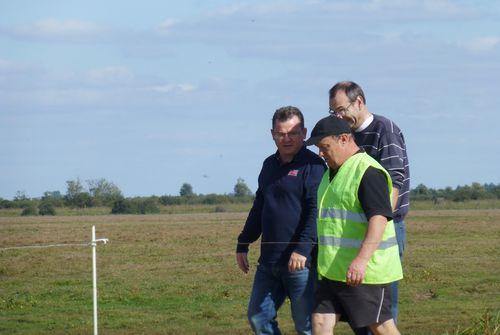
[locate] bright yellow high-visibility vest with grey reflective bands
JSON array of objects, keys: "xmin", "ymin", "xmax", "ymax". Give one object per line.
[{"xmin": 317, "ymin": 153, "xmax": 403, "ymax": 284}]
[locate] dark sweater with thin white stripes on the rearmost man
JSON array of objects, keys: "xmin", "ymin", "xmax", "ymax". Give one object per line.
[{"xmin": 354, "ymin": 114, "xmax": 410, "ymax": 222}]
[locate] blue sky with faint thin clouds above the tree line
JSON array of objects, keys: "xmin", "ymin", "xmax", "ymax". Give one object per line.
[{"xmin": 0, "ymin": 0, "xmax": 500, "ymax": 199}]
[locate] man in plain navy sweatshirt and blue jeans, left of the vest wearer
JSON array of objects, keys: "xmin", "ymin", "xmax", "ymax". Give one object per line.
[{"xmin": 236, "ymin": 106, "xmax": 326, "ymax": 334}]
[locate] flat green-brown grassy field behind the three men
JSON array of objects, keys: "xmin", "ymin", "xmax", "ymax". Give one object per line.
[{"xmin": 0, "ymin": 209, "xmax": 500, "ymax": 334}]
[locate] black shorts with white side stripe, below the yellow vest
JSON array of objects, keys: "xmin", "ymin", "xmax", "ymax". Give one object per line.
[{"xmin": 313, "ymin": 278, "xmax": 392, "ymax": 328}]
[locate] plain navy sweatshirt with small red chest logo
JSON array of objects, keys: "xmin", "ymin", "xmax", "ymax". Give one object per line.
[{"xmin": 236, "ymin": 146, "xmax": 326, "ymax": 264}]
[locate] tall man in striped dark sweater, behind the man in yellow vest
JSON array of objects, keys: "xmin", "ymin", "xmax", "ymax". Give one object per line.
[{"xmin": 329, "ymin": 81, "xmax": 410, "ymax": 334}]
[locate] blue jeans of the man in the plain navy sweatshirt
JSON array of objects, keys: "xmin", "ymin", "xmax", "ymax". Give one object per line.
[{"xmin": 248, "ymin": 264, "xmax": 316, "ymax": 335}]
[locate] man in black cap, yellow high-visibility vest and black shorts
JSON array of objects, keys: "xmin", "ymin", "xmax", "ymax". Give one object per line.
[{"xmin": 306, "ymin": 116, "xmax": 403, "ymax": 335}]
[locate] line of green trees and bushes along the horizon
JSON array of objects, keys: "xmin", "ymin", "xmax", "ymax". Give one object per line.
[{"xmin": 0, "ymin": 178, "xmax": 500, "ymax": 215}]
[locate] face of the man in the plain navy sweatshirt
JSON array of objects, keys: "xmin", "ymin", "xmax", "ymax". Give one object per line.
[{"xmin": 271, "ymin": 115, "xmax": 307, "ymax": 158}]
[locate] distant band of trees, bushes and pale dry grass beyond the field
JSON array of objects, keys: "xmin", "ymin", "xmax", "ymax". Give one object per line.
[{"xmin": 0, "ymin": 178, "xmax": 500, "ymax": 216}]
